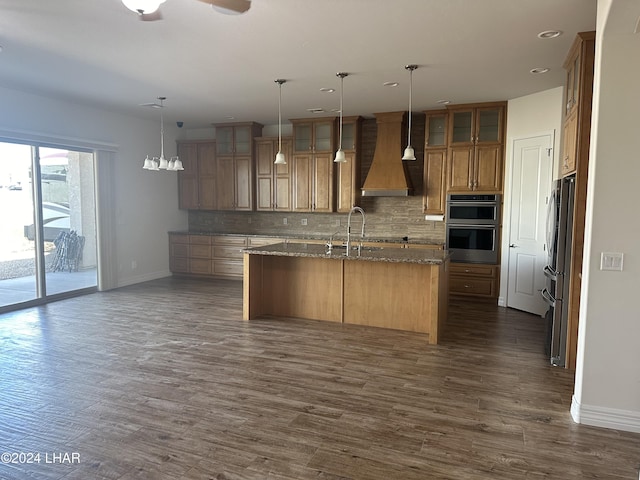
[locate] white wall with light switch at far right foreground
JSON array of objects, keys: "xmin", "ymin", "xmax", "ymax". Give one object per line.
[{"xmin": 572, "ymin": 0, "xmax": 640, "ymax": 432}]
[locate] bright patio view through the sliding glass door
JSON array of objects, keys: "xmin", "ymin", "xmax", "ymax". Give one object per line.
[{"xmin": 0, "ymin": 142, "xmax": 97, "ymax": 308}]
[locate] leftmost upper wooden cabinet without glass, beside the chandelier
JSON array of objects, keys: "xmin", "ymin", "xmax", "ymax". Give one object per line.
[{"xmin": 178, "ymin": 141, "xmax": 217, "ymax": 210}]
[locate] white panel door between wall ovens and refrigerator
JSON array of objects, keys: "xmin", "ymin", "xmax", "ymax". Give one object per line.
[{"xmin": 507, "ymin": 134, "xmax": 553, "ymax": 315}]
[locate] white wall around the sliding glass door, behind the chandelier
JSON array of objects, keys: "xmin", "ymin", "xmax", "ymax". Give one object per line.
[{"xmin": 0, "ymin": 87, "xmax": 187, "ymax": 286}]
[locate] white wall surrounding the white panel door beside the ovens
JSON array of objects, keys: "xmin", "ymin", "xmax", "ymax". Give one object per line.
[{"xmin": 498, "ymin": 87, "xmax": 564, "ymax": 306}]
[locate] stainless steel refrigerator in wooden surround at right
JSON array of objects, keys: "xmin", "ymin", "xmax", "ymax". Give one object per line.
[{"xmin": 542, "ymin": 175, "xmax": 575, "ymax": 367}]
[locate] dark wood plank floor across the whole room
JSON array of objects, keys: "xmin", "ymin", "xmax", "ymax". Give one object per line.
[{"xmin": 0, "ymin": 279, "xmax": 640, "ymax": 480}]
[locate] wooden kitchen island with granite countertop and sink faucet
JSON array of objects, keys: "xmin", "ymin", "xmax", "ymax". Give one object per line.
[{"xmin": 243, "ymin": 243, "xmax": 449, "ymax": 344}]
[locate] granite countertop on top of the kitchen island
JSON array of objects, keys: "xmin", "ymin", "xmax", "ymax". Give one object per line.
[{"xmin": 243, "ymin": 243, "xmax": 449, "ymax": 265}]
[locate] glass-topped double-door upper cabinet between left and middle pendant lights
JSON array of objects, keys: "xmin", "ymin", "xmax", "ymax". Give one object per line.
[{"xmin": 291, "ymin": 117, "xmax": 336, "ymax": 212}]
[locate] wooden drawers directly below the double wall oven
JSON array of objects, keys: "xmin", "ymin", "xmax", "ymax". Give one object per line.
[{"xmin": 449, "ymin": 263, "xmax": 500, "ymax": 298}]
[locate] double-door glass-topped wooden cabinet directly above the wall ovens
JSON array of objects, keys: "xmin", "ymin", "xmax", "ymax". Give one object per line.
[{"xmin": 447, "ymin": 102, "xmax": 506, "ymax": 193}]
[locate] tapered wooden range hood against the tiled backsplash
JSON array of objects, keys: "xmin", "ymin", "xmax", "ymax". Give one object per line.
[{"xmin": 362, "ymin": 112, "xmax": 413, "ymax": 197}]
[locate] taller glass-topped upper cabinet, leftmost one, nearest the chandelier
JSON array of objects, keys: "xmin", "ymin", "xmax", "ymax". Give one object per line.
[{"xmin": 215, "ymin": 122, "xmax": 262, "ymax": 211}]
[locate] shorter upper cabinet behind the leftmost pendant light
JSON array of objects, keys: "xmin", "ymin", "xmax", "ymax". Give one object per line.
[{"xmin": 255, "ymin": 137, "xmax": 293, "ymax": 212}]
